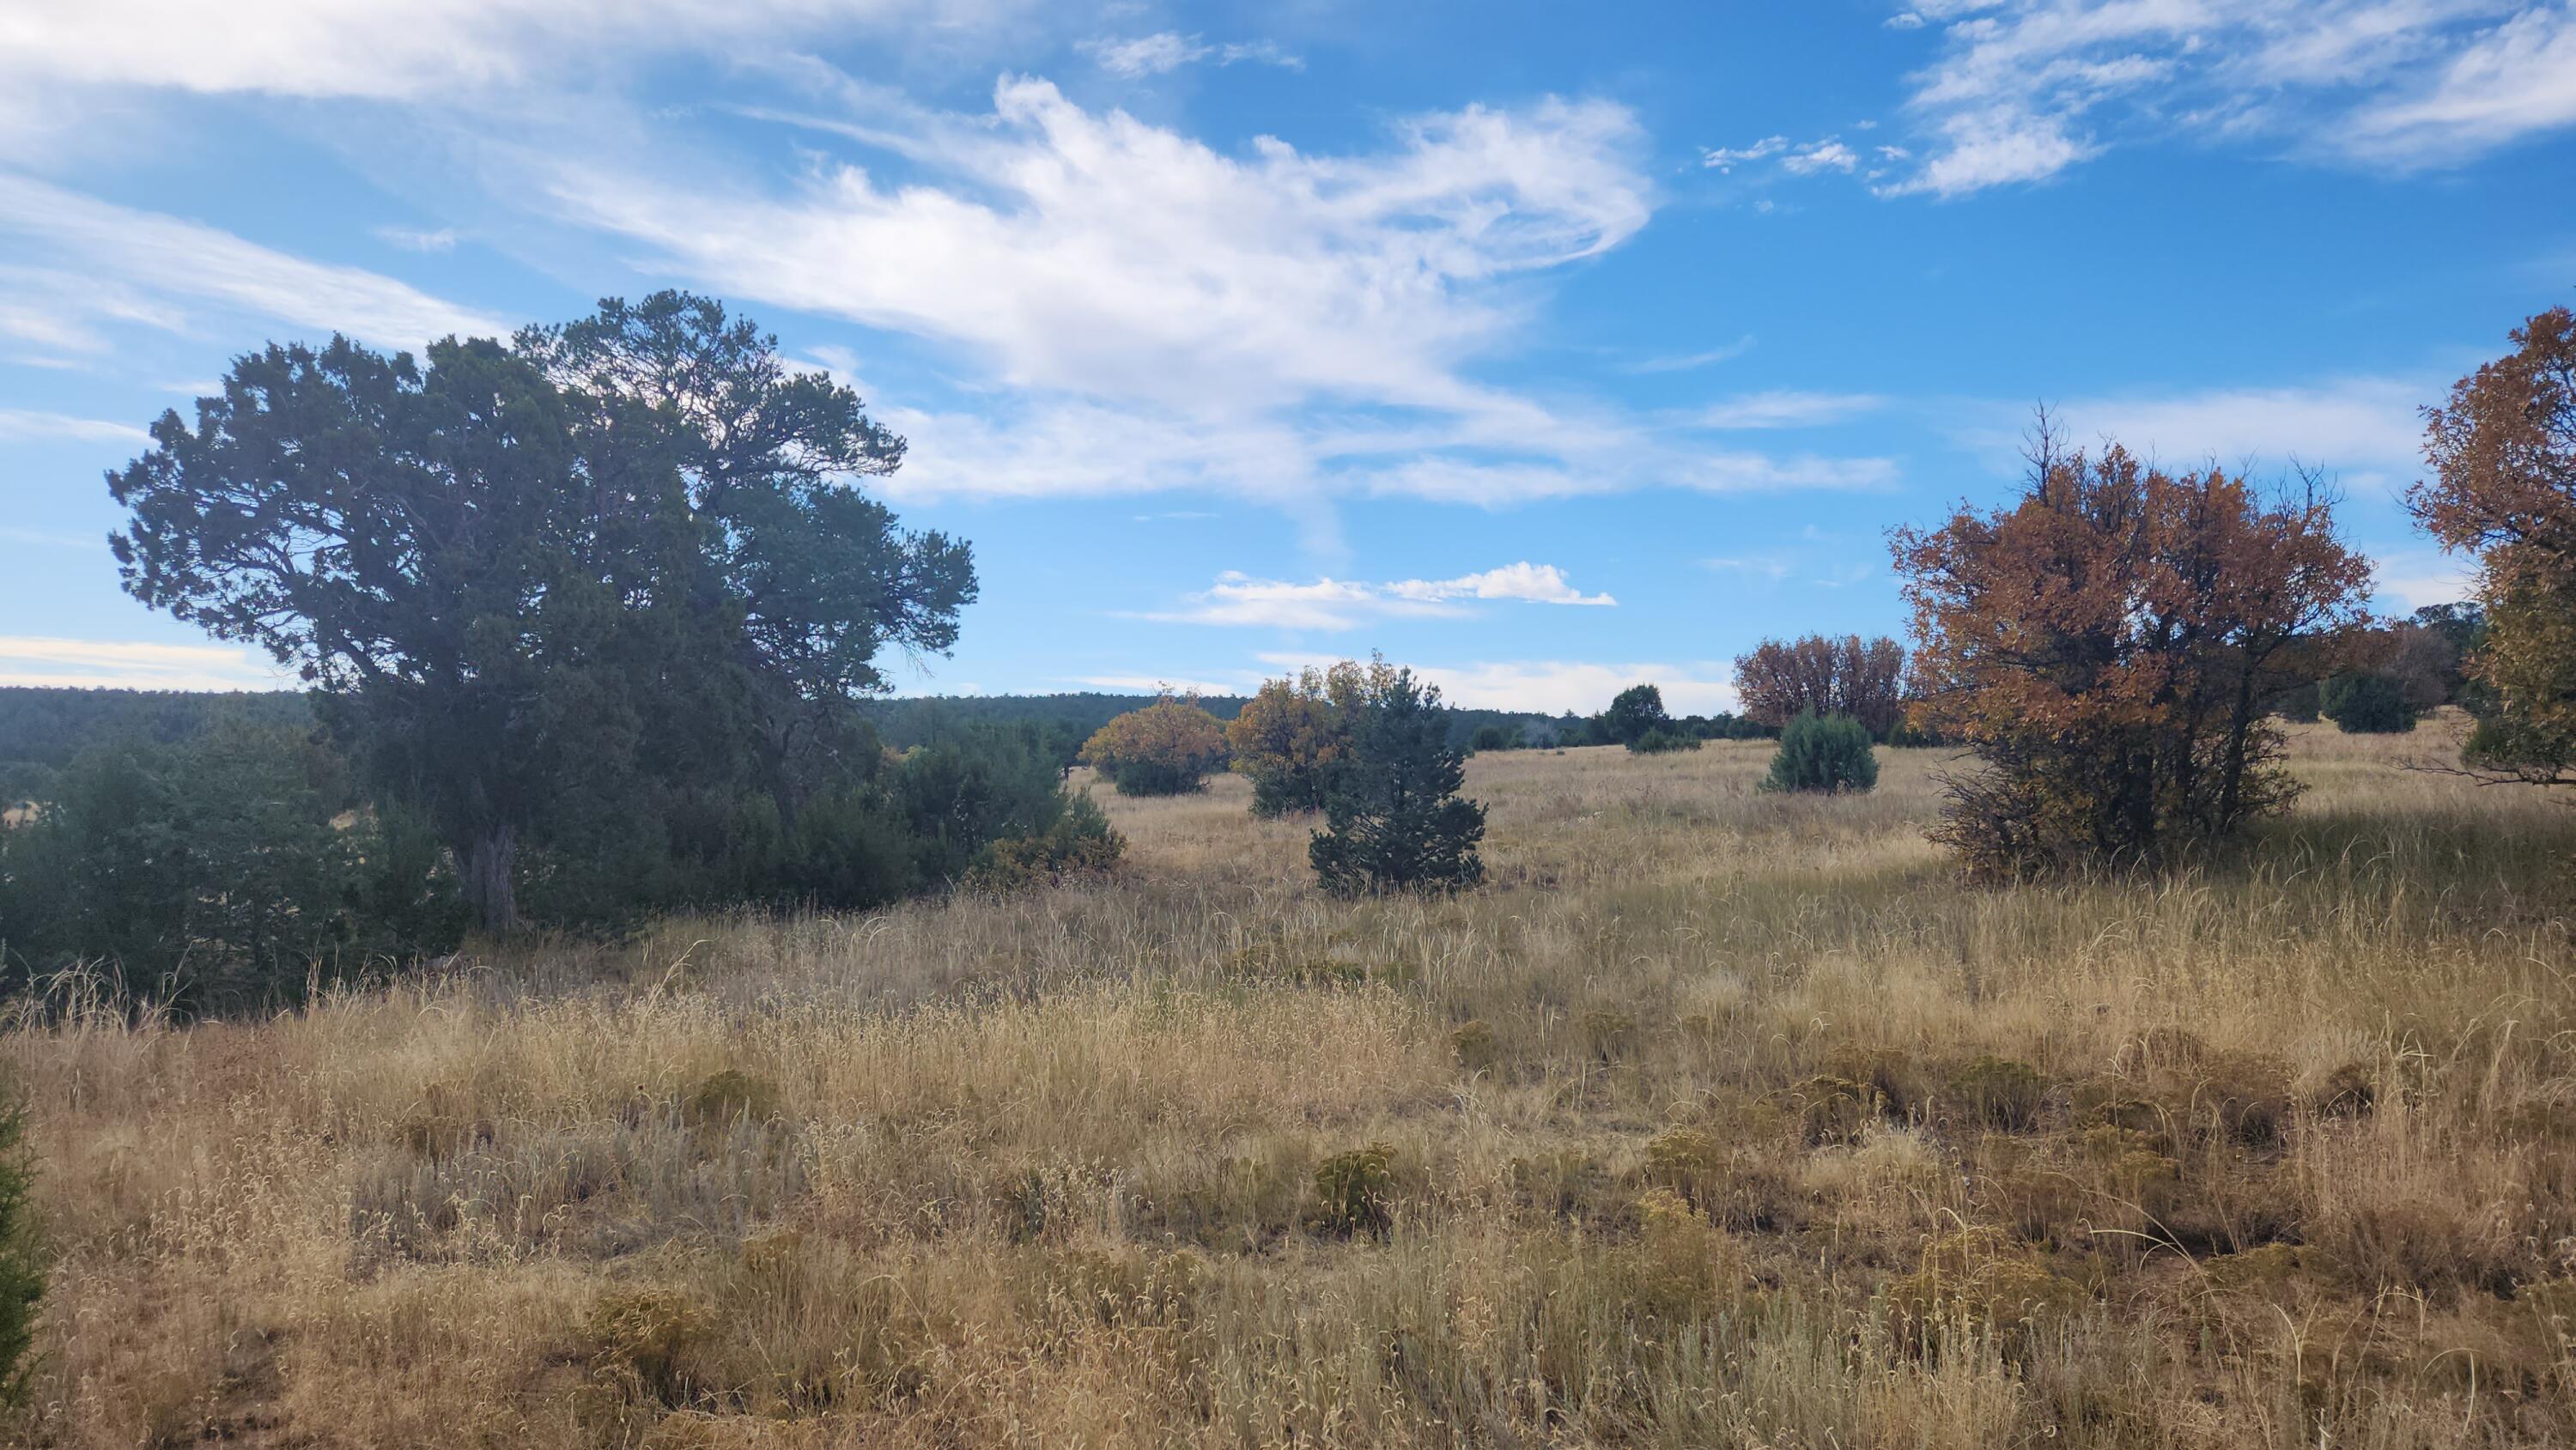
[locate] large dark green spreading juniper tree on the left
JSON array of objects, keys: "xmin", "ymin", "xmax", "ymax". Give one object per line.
[{"xmin": 108, "ymin": 291, "xmax": 976, "ymax": 930}]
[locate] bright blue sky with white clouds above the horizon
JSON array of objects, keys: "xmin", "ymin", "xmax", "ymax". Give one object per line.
[{"xmin": 0, "ymin": 0, "xmax": 2576, "ymax": 711}]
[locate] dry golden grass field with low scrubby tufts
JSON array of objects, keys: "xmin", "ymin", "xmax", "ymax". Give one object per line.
[{"xmin": 5, "ymin": 721, "xmax": 2576, "ymax": 1450}]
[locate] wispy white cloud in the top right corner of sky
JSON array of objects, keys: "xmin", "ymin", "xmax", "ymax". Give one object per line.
[{"xmin": 1883, "ymin": 0, "xmax": 2576, "ymax": 196}]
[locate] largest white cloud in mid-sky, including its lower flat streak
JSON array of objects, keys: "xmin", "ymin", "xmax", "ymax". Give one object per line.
[{"xmin": 549, "ymin": 77, "xmax": 1875, "ymax": 510}]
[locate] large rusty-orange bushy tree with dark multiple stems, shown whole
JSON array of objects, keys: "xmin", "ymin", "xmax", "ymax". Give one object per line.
[{"xmin": 1891, "ymin": 415, "xmax": 2370, "ymax": 876}]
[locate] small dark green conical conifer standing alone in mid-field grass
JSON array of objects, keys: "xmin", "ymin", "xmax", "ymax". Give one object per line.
[{"xmin": 1306, "ymin": 670, "xmax": 1484, "ymax": 894}]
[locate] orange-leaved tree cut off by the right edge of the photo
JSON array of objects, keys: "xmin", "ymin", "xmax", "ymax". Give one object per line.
[{"xmin": 2406, "ymin": 306, "xmax": 2576, "ymax": 786}]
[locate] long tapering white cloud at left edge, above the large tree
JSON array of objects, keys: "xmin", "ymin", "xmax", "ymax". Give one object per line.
[{"xmin": 0, "ymin": 173, "xmax": 505, "ymax": 350}]
